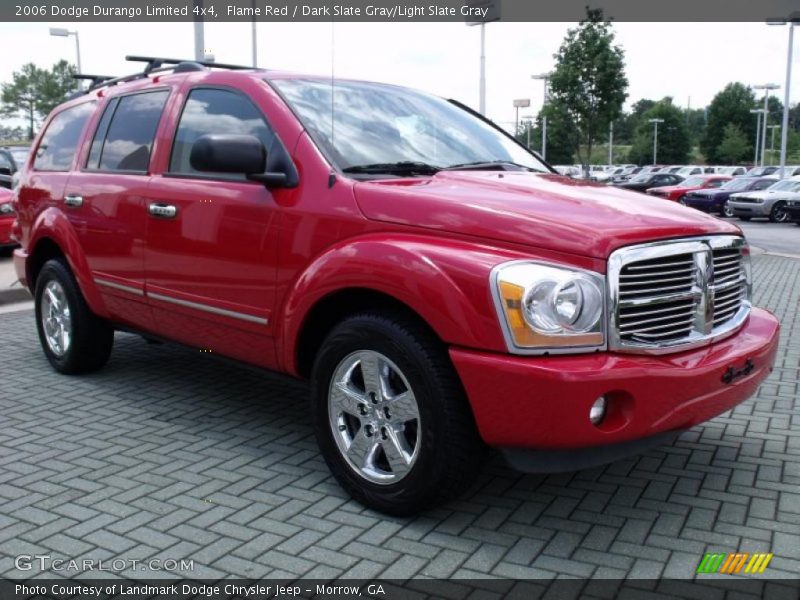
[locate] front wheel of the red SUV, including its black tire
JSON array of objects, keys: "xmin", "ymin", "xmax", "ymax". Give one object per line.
[{"xmin": 312, "ymin": 312, "xmax": 485, "ymax": 516}]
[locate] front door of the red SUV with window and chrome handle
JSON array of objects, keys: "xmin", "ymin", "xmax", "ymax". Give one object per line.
[{"xmin": 145, "ymin": 85, "xmax": 286, "ymax": 366}]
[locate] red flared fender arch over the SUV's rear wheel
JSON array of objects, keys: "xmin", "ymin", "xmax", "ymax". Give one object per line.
[{"xmin": 26, "ymin": 206, "xmax": 109, "ymax": 318}]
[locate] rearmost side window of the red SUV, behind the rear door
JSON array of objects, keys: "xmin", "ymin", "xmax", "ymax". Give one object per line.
[{"xmin": 33, "ymin": 102, "xmax": 95, "ymax": 171}]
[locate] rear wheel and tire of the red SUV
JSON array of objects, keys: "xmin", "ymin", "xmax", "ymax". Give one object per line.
[{"xmin": 34, "ymin": 259, "xmax": 114, "ymax": 375}]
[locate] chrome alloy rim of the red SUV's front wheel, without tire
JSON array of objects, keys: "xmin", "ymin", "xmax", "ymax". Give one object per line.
[{"xmin": 328, "ymin": 350, "xmax": 422, "ymax": 485}]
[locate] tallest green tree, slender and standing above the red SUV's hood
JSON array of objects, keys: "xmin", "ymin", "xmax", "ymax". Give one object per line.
[{"xmin": 548, "ymin": 8, "xmax": 628, "ymax": 173}]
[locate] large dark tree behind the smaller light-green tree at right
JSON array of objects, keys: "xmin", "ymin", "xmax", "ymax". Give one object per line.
[{"xmin": 700, "ymin": 82, "xmax": 756, "ymax": 164}]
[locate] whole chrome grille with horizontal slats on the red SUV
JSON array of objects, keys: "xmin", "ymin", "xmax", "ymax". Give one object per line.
[{"xmin": 608, "ymin": 236, "xmax": 750, "ymax": 353}]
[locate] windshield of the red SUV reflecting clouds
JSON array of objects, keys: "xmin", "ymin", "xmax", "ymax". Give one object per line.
[{"xmin": 272, "ymin": 79, "xmax": 550, "ymax": 173}]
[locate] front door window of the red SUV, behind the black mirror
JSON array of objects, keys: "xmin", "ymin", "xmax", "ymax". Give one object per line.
[{"xmin": 169, "ymin": 88, "xmax": 275, "ymax": 179}]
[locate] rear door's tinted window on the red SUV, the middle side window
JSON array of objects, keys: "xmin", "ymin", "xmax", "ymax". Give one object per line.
[{"xmin": 97, "ymin": 90, "xmax": 169, "ymax": 172}]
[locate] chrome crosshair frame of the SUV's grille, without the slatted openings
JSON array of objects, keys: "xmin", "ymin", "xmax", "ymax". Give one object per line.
[{"xmin": 607, "ymin": 235, "xmax": 752, "ymax": 355}]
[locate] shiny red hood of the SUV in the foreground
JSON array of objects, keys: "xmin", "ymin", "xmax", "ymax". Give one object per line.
[{"xmin": 355, "ymin": 171, "xmax": 740, "ymax": 259}]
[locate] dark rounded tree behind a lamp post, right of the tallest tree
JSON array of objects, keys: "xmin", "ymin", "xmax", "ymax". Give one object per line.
[{"xmin": 628, "ymin": 97, "xmax": 692, "ymax": 165}]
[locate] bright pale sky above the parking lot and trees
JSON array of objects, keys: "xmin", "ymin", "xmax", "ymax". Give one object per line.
[{"xmin": 0, "ymin": 22, "xmax": 800, "ymax": 129}]
